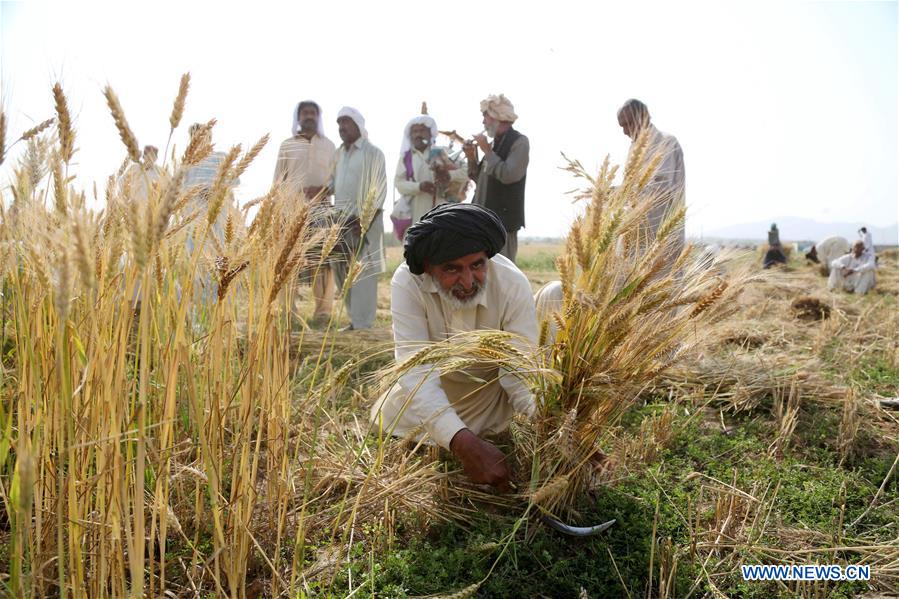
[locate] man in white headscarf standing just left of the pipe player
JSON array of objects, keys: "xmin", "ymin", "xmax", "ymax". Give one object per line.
[{"xmin": 394, "ymin": 114, "xmax": 468, "ymax": 223}]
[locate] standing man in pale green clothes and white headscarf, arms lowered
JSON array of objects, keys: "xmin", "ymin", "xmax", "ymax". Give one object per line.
[{"xmin": 331, "ymin": 106, "xmax": 387, "ymax": 330}]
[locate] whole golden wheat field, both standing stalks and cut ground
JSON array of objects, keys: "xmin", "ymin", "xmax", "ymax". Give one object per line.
[{"xmin": 0, "ymin": 81, "xmax": 899, "ymax": 598}]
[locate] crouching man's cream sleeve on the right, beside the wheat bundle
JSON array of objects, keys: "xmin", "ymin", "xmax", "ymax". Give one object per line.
[{"xmin": 499, "ymin": 270, "xmax": 538, "ymax": 416}]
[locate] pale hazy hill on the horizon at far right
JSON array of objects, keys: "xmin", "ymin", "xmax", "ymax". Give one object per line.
[{"xmin": 703, "ymin": 216, "xmax": 899, "ymax": 246}]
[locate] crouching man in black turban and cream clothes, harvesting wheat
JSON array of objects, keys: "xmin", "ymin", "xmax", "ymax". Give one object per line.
[{"xmin": 372, "ymin": 204, "xmax": 537, "ymax": 488}]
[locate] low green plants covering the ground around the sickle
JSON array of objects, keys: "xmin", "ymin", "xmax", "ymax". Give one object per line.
[{"xmin": 312, "ymin": 394, "xmax": 899, "ymax": 598}]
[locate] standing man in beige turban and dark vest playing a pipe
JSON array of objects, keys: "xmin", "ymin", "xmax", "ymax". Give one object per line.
[{"xmin": 464, "ymin": 94, "xmax": 530, "ymax": 262}]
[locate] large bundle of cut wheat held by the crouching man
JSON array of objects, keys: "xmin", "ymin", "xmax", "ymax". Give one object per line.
[{"xmin": 384, "ymin": 135, "xmax": 760, "ymax": 515}]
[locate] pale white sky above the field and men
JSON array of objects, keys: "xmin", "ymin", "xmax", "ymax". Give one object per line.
[{"xmin": 0, "ymin": 0, "xmax": 899, "ymax": 236}]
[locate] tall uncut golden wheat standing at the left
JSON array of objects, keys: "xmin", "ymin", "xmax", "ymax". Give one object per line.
[{"xmin": 0, "ymin": 81, "xmax": 454, "ymax": 597}]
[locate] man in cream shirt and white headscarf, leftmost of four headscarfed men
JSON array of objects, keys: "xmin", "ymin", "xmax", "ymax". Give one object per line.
[{"xmin": 273, "ymin": 100, "xmax": 336, "ymax": 326}]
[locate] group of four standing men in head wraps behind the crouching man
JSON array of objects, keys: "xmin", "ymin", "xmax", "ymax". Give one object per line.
[{"xmin": 274, "ymin": 95, "xmax": 529, "ymax": 330}]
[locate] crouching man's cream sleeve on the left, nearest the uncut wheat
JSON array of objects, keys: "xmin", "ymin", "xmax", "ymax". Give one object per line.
[{"xmin": 390, "ymin": 271, "xmax": 466, "ymax": 449}]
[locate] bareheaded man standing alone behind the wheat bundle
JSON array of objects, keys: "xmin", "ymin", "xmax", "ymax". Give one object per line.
[{"xmin": 618, "ymin": 99, "xmax": 686, "ymax": 260}]
